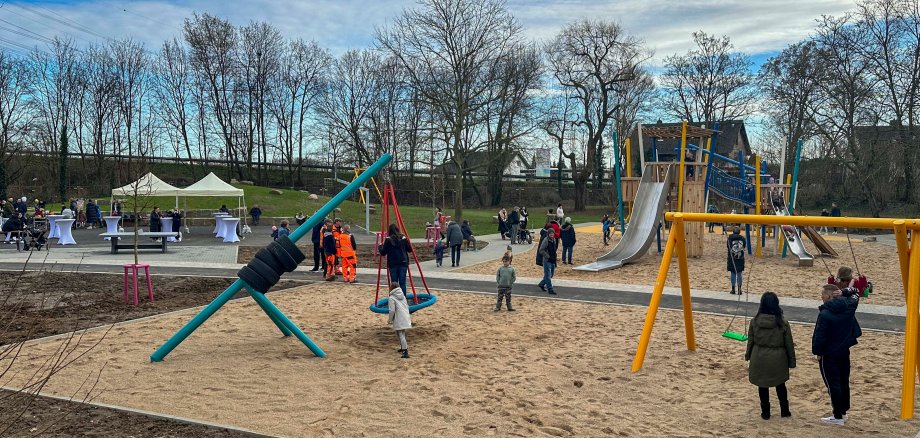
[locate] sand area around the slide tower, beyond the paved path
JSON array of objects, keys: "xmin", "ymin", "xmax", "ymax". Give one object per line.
[{"xmin": 468, "ymin": 231, "xmax": 904, "ymax": 306}]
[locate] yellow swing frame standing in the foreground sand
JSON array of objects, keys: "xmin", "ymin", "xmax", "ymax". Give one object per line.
[{"xmin": 632, "ymin": 212, "xmax": 920, "ymax": 420}]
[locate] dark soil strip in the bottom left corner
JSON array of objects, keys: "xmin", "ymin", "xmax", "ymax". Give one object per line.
[{"xmin": 0, "ymin": 391, "xmax": 251, "ymax": 437}]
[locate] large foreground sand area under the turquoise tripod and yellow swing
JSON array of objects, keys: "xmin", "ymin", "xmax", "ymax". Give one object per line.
[{"xmin": 0, "ymin": 284, "xmax": 920, "ymax": 437}]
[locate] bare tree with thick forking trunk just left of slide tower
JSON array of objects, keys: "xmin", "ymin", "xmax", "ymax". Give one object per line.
[{"xmin": 546, "ymin": 20, "xmax": 649, "ymax": 211}]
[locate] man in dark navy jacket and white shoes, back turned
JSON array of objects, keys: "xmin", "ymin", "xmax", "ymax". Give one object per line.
[{"xmin": 811, "ymin": 284, "xmax": 862, "ymax": 426}]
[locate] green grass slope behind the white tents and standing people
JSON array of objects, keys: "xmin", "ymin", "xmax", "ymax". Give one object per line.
[{"xmin": 109, "ymin": 184, "xmax": 615, "ymax": 237}]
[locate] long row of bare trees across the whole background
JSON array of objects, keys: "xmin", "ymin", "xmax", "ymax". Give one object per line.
[{"xmin": 0, "ymin": 0, "xmax": 920, "ymax": 217}]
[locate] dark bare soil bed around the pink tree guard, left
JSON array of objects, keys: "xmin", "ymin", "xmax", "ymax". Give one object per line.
[{"xmin": 0, "ymin": 272, "xmax": 304, "ymax": 345}]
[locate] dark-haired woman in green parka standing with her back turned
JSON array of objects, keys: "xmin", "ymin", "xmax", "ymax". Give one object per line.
[{"xmin": 744, "ymin": 292, "xmax": 795, "ymax": 420}]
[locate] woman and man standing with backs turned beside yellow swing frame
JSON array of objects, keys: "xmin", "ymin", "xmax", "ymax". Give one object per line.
[{"xmin": 744, "ymin": 267, "xmax": 862, "ymax": 426}]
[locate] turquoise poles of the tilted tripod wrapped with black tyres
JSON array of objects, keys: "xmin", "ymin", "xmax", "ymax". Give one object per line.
[{"xmin": 150, "ymin": 154, "xmax": 393, "ymax": 362}]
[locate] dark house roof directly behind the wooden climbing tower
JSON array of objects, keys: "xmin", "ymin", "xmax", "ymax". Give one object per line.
[{"xmin": 630, "ymin": 120, "xmax": 751, "ymax": 158}]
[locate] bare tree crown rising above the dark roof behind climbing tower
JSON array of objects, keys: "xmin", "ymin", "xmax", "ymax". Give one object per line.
[{"xmin": 661, "ymin": 31, "xmax": 758, "ymax": 123}]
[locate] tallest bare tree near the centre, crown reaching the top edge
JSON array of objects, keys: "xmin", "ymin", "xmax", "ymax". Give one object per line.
[{"xmin": 377, "ymin": 0, "xmax": 521, "ymax": 220}]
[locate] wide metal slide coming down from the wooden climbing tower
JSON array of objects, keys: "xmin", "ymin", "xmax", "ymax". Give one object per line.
[{"xmin": 575, "ymin": 164, "xmax": 674, "ymax": 272}]
